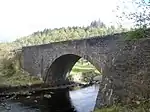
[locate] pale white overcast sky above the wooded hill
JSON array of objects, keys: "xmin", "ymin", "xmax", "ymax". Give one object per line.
[{"xmin": 0, "ymin": 0, "xmax": 143, "ymax": 41}]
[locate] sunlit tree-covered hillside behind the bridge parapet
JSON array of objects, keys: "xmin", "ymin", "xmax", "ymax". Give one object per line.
[{"xmin": 13, "ymin": 20, "xmax": 127, "ymax": 47}]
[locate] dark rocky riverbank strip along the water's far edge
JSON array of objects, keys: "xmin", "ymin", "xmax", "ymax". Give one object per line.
[{"xmin": 0, "ymin": 82, "xmax": 92, "ymax": 97}]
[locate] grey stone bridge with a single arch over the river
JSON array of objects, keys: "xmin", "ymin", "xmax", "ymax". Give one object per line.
[{"xmin": 23, "ymin": 34, "xmax": 150, "ymax": 108}]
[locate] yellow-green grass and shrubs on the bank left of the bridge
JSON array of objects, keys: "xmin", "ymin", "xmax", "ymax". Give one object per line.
[{"xmin": 0, "ymin": 43, "xmax": 41, "ymax": 86}]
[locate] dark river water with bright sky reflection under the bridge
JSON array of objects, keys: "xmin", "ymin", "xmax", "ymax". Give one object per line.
[{"xmin": 0, "ymin": 85, "xmax": 99, "ymax": 112}]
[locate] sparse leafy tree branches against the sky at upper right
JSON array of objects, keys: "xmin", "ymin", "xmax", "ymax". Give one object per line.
[{"xmin": 117, "ymin": 0, "xmax": 150, "ymax": 28}]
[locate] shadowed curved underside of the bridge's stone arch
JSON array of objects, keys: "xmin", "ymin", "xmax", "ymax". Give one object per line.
[{"xmin": 44, "ymin": 54, "xmax": 101, "ymax": 85}]
